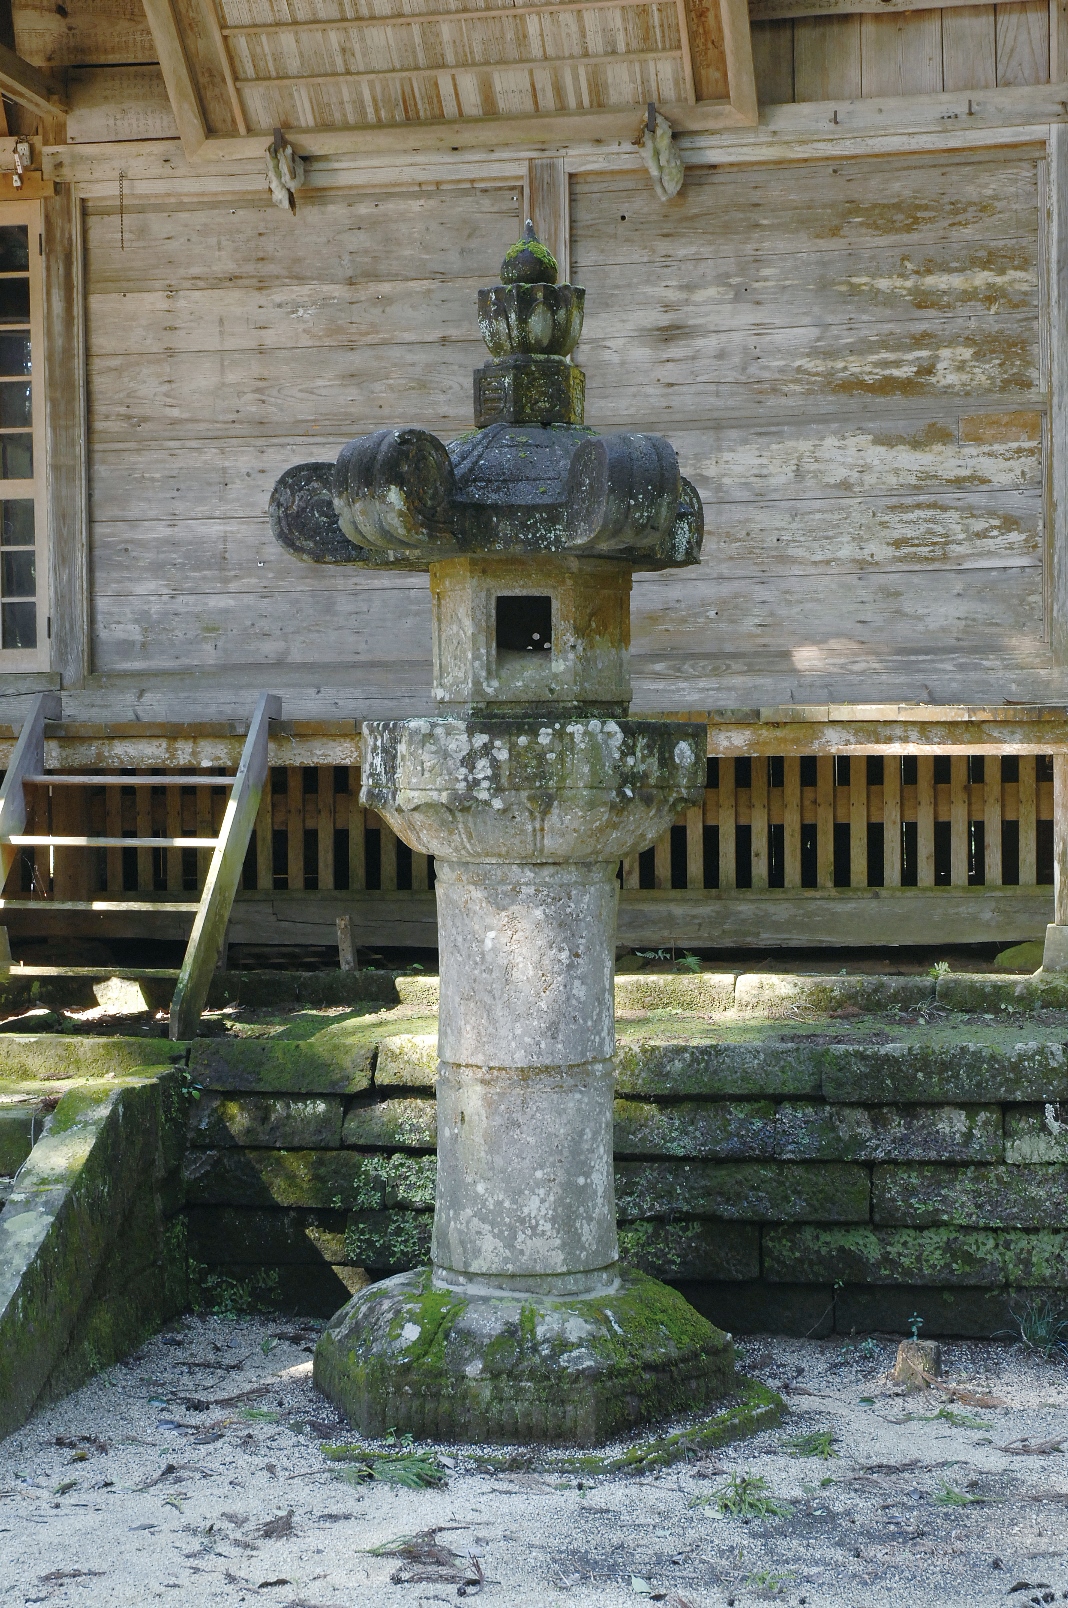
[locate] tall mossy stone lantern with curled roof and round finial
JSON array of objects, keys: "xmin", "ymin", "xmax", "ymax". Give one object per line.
[{"xmin": 270, "ymin": 224, "xmax": 733, "ymax": 1444}]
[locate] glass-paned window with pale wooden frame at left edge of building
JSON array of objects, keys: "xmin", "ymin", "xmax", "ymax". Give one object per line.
[{"xmin": 0, "ymin": 204, "xmax": 48, "ymax": 672}]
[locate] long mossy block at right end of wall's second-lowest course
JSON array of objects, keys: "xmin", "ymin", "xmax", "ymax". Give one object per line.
[{"xmin": 764, "ymin": 1224, "xmax": 1068, "ymax": 1288}]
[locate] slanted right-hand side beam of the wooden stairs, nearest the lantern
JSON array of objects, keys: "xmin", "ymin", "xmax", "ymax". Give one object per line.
[{"xmin": 170, "ymin": 693, "xmax": 281, "ymax": 1039}]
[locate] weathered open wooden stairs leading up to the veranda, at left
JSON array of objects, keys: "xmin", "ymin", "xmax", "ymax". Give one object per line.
[{"xmin": 0, "ymin": 693, "xmax": 281, "ymax": 1039}]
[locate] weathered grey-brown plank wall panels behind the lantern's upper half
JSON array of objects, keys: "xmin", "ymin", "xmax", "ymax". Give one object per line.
[{"xmin": 77, "ymin": 150, "xmax": 1063, "ymax": 714}]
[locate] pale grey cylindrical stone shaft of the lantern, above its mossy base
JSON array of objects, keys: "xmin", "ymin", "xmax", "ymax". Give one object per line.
[{"xmin": 433, "ymin": 860, "xmax": 618, "ymax": 1294}]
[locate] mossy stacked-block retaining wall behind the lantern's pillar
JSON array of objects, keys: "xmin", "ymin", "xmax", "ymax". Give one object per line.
[{"xmin": 185, "ymin": 978, "xmax": 1068, "ymax": 1335}]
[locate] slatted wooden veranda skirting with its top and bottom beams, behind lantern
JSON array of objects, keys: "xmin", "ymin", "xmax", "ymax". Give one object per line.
[{"xmin": 0, "ymin": 708, "xmax": 1068, "ymax": 946}]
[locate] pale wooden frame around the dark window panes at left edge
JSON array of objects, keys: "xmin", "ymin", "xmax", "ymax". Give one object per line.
[{"xmin": 0, "ymin": 201, "xmax": 51, "ymax": 675}]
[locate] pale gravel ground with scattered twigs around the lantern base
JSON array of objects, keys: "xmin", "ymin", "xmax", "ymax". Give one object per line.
[{"xmin": 0, "ymin": 1317, "xmax": 1068, "ymax": 1608}]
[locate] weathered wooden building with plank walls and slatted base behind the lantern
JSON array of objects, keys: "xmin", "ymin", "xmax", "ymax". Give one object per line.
[{"xmin": 0, "ymin": 0, "xmax": 1068, "ymax": 946}]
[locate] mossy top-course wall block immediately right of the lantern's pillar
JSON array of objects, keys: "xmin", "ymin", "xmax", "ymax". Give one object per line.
[{"xmin": 616, "ymin": 1039, "xmax": 824, "ymax": 1100}]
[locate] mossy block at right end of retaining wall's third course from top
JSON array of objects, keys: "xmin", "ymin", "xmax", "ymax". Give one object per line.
[{"xmin": 872, "ymin": 1166, "xmax": 1068, "ymax": 1229}]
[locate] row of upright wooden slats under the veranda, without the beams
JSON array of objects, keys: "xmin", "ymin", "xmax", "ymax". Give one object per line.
[{"xmin": 5, "ymin": 754, "xmax": 1054, "ymax": 899}]
